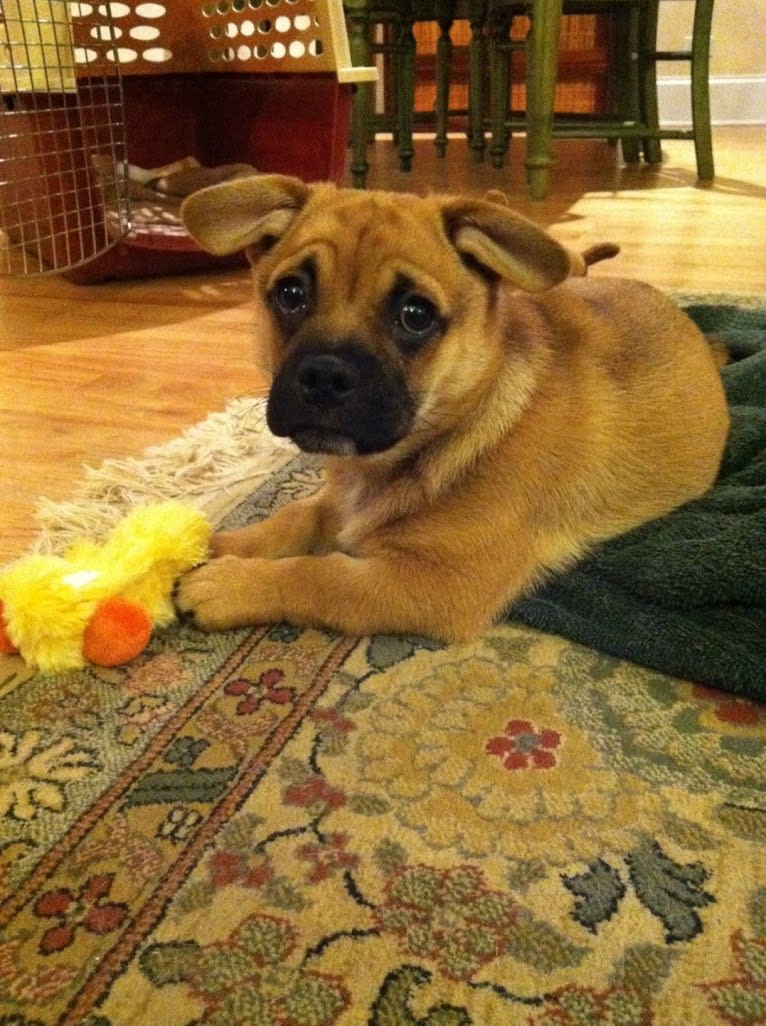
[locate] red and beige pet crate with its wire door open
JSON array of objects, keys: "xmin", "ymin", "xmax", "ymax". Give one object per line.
[{"xmin": 0, "ymin": 0, "xmax": 375, "ymax": 283}]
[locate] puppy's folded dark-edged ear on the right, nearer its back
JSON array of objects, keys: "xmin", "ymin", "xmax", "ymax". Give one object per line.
[{"xmin": 442, "ymin": 197, "xmax": 570, "ymax": 292}]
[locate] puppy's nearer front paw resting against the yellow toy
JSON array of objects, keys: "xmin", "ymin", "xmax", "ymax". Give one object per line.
[{"xmin": 174, "ymin": 556, "xmax": 260, "ymax": 631}]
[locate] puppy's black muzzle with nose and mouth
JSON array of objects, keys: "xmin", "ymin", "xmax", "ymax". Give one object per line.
[{"xmin": 267, "ymin": 343, "xmax": 412, "ymax": 456}]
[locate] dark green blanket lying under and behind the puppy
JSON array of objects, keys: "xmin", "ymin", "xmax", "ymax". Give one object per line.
[{"xmin": 509, "ymin": 306, "xmax": 766, "ymax": 701}]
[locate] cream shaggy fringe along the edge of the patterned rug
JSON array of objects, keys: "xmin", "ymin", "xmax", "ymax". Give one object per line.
[{"xmin": 34, "ymin": 398, "xmax": 297, "ymax": 552}]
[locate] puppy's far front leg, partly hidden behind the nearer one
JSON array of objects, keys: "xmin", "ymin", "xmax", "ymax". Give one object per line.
[{"xmin": 210, "ymin": 492, "xmax": 332, "ymax": 559}]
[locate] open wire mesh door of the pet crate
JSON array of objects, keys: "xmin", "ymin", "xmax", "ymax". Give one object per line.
[{"xmin": 0, "ymin": 0, "xmax": 129, "ymax": 275}]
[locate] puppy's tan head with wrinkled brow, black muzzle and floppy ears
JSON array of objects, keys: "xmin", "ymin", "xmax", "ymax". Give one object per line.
[{"xmin": 182, "ymin": 175, "xmax": 570, "ymax": 456}]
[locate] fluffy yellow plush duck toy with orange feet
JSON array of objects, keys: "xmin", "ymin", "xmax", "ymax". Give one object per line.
[{"xmin": 0, "ymin": 502, "xmax": 211, "ymax": 673}]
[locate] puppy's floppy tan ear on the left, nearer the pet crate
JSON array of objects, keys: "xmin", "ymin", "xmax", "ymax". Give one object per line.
[{"xmin": 180, "ymin": 174, "xmax": 311, "ymax": 257}]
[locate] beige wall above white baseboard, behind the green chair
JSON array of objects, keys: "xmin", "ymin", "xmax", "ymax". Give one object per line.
[{"xmin": 659, "ymin": 0, "xmax": 766, "ymax": 76}]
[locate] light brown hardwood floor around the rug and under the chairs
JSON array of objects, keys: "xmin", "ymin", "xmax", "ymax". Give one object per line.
[{"xmin": 0, "ymin": 127, "xmax": 766, "ymax": 562}]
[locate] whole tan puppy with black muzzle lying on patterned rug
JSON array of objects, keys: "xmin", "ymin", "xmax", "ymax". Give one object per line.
[{"xmin": 177, "ymin": 175, "xmax": 728, "ymax": 641}]
